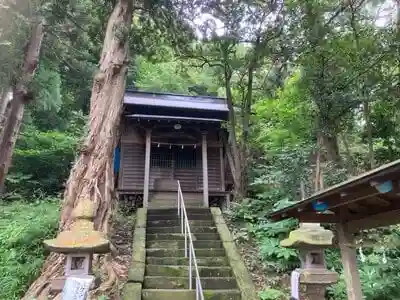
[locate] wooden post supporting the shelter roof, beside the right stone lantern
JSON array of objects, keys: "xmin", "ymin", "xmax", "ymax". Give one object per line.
[{"xmin": 336, "ymin": 224, "xmax": 363, "ymax": 300}]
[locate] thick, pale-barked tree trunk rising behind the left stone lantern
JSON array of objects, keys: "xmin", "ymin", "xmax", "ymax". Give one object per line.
[{"xmin": 24, "ymin": 0, "xmax": 133, "ymax": 299}]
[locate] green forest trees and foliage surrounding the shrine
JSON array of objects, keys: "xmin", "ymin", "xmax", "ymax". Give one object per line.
[{"xmin": 0, "ymin": 0, "xmax": 400, "ymax": 300}]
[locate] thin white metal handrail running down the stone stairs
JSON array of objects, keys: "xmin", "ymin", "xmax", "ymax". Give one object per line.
[{"xmin": 178, "ymin": 180, "xmax": 204, "ymax": 300}]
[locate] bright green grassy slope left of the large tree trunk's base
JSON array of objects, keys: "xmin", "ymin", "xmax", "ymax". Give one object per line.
[{"xmin": 0, "ymin": 199, "xmax": 59, "ymax": 300}]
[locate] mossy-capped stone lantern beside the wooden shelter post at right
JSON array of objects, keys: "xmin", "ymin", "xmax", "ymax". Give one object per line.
[{"xmin": 281, "ymin": 223, "xmax": 338, "ymax": 300}]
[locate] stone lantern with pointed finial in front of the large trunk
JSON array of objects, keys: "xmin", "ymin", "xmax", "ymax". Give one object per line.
[{"xmin": 44, "ymin": 200, "xmax": 110, "ymax": 292}]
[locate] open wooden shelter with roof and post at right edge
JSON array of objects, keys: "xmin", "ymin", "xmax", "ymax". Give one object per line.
[{"xmin": 269, "ymin": 160, "xmax": 400, "ymax": 300}]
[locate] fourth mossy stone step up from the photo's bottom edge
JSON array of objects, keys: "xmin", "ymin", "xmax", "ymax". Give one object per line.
[{"xmin": 146, "ymin": 255, "xmax": 229, "ymax": 266}]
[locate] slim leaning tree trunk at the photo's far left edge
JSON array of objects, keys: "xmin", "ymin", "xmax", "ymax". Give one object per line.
[{"xmin": 0, "ymin": 21, "xmax": 44, "ymax": 191}]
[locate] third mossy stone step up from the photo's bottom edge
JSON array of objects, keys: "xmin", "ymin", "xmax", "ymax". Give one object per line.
[{"xmin": 145, "ymin": 265, "xmax": 233, "ymax": 278}]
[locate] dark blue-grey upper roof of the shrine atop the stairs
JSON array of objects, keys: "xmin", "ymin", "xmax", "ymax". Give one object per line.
[{"xmin": 124, "ymin": 90, "xmax": 229, "ymax": 112}]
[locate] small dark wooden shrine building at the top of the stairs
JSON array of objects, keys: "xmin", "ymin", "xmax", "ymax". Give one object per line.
[{"xmin": 117, "ymin": 90, "xmax": 231, "ymax": 207}]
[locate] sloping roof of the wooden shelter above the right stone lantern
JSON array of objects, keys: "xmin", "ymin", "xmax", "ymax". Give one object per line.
[{"xmin": 269, "ymin": 160, "xmax": 400, "ymax": 230}]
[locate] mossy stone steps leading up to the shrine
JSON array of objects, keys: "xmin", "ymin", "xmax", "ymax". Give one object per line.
[{"xmin": 142, "ymin": 208, "xmax": 241, "ymax": 300}]
